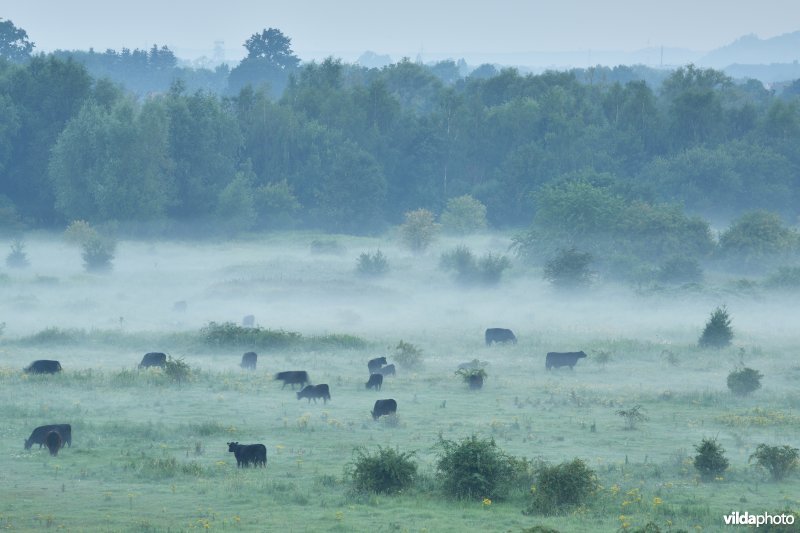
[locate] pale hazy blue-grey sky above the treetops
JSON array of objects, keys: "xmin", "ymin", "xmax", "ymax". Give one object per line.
[{"xmin": 0, "ymin": 0, "xmax": 800, "ymax": 60}]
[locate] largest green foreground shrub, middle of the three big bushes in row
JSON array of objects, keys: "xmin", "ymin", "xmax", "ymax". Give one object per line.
[{"xmin": 436, "ymin": 435, "xmax": 531, "ymax": 499}]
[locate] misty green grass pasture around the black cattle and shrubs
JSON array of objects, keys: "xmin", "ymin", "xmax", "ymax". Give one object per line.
[{"xmin": 0, "ymin": 234, "xmax": 800, "ymax": 532}]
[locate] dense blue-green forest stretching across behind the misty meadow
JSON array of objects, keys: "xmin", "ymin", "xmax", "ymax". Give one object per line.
[{"xmin": 0, "ymin": 23, "xmax": 800, "ymax": 274}]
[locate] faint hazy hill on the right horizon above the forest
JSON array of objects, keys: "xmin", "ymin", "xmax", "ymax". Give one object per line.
[{"xmin": 698, "ymin": 31, "xmax": 800, "ymax": 68}]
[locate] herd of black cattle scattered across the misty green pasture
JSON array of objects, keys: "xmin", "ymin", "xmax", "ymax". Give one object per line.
[{"xmin": 17, "ymin": 326, "xmax": 586, "ymax": 468}]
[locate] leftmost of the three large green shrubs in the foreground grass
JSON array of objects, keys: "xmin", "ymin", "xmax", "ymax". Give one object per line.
[{"xmin": 349, "ymin": 446, "xmax": 417, "ymax": 494}]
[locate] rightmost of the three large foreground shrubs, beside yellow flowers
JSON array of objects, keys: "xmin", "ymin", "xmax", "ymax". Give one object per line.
[{"xmin": 527, "ymin": 459, "xmax": 598, "ymax": 514}]
